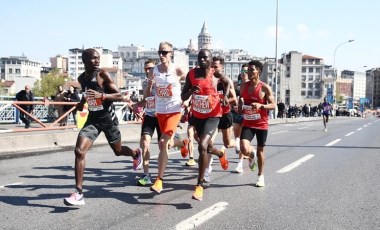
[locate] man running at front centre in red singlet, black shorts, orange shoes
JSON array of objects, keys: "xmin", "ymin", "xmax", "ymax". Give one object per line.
[{"xmin": 181, "ymin": 49, "xmax": 230, "ymax": 200}]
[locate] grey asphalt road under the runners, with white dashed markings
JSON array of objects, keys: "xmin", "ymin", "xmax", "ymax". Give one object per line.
[{"xmin": 0, "ymin": 117, "xmax": 380, "ymax": 230}]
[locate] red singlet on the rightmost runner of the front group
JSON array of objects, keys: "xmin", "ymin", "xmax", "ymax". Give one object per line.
[{"xmin": 242, "ymin": 82, "xmax": 268, "ymax": 130}]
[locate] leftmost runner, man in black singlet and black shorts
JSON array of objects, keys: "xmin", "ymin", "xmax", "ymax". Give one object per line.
[{"xmin": 64, "ymin": 49, "xmax": 142, "ymax": 205}]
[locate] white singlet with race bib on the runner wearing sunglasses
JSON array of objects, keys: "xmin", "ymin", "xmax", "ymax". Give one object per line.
[{"xmin": 153, "ymin": 63, "xmax": 182, "ymax": 114}]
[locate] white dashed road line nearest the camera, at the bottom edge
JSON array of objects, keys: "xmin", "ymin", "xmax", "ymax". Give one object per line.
[{"xmin": 175, "ymin": 202, "xmax": 228, "ymax": 230}]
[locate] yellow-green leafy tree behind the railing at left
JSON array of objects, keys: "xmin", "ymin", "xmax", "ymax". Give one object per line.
[{"xmin": 33, "ymin": 69, "xmax": 65, "ymax": 97}]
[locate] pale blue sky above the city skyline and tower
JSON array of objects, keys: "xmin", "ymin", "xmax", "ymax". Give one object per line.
[{"xmin": 0, "ymin": 0, "xmax": 380, "ymax": 71}]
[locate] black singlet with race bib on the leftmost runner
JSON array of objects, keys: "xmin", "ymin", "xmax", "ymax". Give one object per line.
[{"xmin": 78, "ymin": 68, "xmax": 116, "ymax": 124}]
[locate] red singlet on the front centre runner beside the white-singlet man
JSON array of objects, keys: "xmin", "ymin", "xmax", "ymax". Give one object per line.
[{"xmin": 189, "ymin": 69, "xmax": 222, "ymax": 119}]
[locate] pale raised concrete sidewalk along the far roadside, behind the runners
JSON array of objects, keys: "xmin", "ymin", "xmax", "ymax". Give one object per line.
[{"xmin": 0, "ymin": 117, "xmax": 322, "ymax": 159}]
